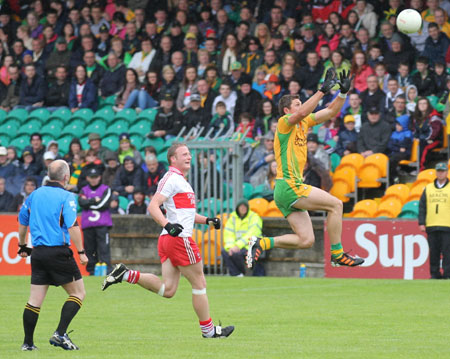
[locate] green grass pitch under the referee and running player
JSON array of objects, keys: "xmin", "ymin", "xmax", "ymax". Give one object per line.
[{"xmin": 0, "ymin": 276, "xmax": 450, "ymax": 359}]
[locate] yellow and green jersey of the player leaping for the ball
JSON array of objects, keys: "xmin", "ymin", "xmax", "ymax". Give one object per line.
[{"xmin": 274, "ymin": 113, "xmax": 317, "ymax": 183}]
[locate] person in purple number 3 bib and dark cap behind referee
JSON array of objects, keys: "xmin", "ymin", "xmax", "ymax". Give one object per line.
[{"xmin": 78, "ymin": 167, "xmax": 113, "ymax": 275}]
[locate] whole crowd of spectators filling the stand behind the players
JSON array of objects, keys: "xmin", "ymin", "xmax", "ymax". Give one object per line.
[{"xmin": 0, "ymin": 0, "xmax": 450, "ymax": 213}]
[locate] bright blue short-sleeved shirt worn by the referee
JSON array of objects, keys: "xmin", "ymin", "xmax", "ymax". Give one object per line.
[{"xmin": 19, "ymin": 181, "xmax": 77, "ymax": 247}]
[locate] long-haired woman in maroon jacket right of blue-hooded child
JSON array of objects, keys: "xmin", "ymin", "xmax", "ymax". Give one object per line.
[{"xmin": 413, "ymin": 97, "xmax": 443, "ymax": 171}]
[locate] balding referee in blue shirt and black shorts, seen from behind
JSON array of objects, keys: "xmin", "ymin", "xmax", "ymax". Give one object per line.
[{"xmin": 19, "ymin": 160, "xmax": 88, "ymax": 351}]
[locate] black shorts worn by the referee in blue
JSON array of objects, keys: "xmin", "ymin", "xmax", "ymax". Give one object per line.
[{"xmin": 31, "ymin": 246, "xmax": 81, "ymax": 286}]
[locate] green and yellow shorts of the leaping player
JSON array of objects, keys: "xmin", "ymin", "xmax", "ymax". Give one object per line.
[{"xmin": 273, "ymin": 179, "xmax": 312, "ymax": 217}]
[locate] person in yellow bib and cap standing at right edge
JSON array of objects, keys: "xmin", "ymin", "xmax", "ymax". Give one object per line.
[{"xmin": 418, "ymin": 162, "xmax": 450, "ymax": 279}]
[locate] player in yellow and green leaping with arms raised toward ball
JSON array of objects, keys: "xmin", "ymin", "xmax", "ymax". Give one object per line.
[{"xmin": 247, "ymin": 68, "xmax": 364, "ymax": 268}]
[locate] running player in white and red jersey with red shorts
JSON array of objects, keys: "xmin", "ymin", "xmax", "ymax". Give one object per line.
[{"xmin": 102, "ymin": 143, "xmax": 234, "ymax": 338}]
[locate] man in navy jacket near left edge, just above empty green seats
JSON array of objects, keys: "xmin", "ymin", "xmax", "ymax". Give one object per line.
[{"xmin": 18, "ymin": 64, "xmax": 45, "ymax": 111}]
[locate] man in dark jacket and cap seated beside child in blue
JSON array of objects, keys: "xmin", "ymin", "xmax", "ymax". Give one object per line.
[{"xmin": 357, "ymin": 107, "xmax": 391, "ymax": 157}]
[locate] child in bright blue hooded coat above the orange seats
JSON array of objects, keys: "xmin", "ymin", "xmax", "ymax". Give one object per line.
[{"xmin": 387, "ymin": 115, "xmax": 413, "ymax": 183}]
